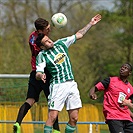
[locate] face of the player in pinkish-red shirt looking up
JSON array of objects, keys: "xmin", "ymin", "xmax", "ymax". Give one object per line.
[{"xmin": 120, "ymin": 64, "xmax": 130, "ymax": 77}]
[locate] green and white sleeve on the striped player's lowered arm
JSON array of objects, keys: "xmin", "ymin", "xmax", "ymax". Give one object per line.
[{"xmin": 36, "ymin": 52, "xmax": 46, "ymax": 73}]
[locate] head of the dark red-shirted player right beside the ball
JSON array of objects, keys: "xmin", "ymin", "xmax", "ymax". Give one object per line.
[{"xmin": 34, "ymin": 18, "xmax": 50, "ymax": 35}]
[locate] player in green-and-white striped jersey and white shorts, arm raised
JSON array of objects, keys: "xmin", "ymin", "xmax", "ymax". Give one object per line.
[{"xmin": 36, "ymin": 14, "xmax": 101, "ymax": 133}]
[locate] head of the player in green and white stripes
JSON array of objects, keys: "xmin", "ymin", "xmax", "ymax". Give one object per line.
[{"xmin": 36, "ymin": 33, "xmax": 54, "ymax": 50}]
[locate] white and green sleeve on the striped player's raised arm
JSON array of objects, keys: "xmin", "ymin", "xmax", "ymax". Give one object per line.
[{"xmin": 61, "ymin": 35, "xmax": 76, "ymax": 48}]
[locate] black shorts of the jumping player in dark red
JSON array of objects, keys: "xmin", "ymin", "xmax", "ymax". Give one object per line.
[{"xmin": 26, "ymin": 71, "xmax": 50, "ymax": 102}]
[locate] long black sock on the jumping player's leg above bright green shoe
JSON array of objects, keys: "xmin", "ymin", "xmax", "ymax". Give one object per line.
[{"xmin": 16, "ymin": 102, "xmax": 31, "ymax": 125}]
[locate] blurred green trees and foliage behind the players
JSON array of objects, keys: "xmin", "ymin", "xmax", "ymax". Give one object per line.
[{"xmin": 0, "ymin": 0, "xmax": 133, "ymax": 103}]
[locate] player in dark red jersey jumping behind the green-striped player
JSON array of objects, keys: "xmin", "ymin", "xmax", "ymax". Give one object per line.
[{"xmin": 13, "ymin": 18, "xmax": 60, "ymax": 133}]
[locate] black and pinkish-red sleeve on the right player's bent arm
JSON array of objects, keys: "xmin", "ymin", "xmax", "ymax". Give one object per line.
[{"xmin": 95, "ymin": 78, "xmax": 110, "ymax": 91}]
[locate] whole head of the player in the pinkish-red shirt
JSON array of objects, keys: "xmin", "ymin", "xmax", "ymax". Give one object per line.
[{"xmin": 120, "ymin": 63, "xmax": 132, "ymax": 77}]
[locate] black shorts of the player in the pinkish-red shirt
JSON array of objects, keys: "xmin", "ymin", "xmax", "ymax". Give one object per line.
[{"xmin": 107, "ymin": 120, "xmax": 133, "ymax": 133}]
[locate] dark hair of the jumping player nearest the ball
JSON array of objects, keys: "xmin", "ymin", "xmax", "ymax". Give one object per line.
[{"xmin": 34, "ymin": 18, "xmax": 49, "ymax": 30}]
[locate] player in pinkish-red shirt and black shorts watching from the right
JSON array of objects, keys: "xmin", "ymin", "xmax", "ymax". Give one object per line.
[{"xmin": 89, "ymin": 63, "xmax": 133, "ymax": 133}]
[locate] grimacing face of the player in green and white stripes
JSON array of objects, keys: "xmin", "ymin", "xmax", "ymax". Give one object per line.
[{"xmin": 41, "ymin": 36, "xmax": 54, "ymax": 50}]
